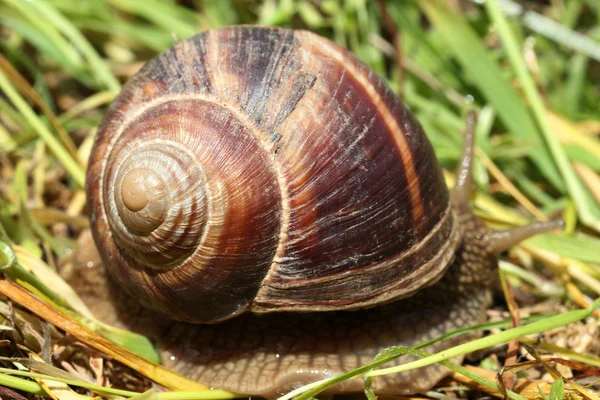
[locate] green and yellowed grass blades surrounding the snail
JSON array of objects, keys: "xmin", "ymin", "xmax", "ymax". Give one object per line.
[{"xmin": 0, "ymin": 0, "xmax": 600, "ymax": 398}]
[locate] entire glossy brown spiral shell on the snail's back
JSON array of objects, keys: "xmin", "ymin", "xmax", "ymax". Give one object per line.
[{"xmin": 87, "ymin": 27, "xmax": 460, "ymax": 322}]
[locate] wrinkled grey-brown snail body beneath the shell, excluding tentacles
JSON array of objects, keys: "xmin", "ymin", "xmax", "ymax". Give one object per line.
[{"xmin": 70, "ymin": 211, "xmax": 495, "ymax": 398}]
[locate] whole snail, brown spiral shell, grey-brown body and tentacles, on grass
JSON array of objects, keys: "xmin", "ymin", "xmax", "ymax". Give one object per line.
[{"xmin": 77, "ymin": 26, "xmax": 557, "ymax": 397}]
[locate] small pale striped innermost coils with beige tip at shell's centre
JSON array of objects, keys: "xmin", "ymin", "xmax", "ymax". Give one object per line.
[{"xmin": 105, "ymin": 139, "xmax": 210, "ymax": 270}]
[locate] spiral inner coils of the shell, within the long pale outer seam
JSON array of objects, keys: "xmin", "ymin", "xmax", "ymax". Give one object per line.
[{"xmin": 95, "ymin": 96, "xmax": 281, "ymax": 320}]
